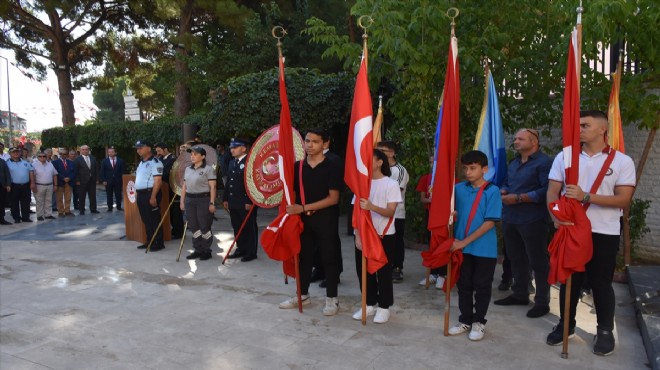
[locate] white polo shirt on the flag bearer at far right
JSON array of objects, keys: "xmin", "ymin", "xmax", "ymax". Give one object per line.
[{"xmin": 548, "ymin": 152, "xmax": 635, "ymax": 235}]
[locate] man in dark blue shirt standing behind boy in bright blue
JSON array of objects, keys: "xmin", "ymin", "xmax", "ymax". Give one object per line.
[{"xmin": 494, "ymin": 129, "xmax": 552, "ymax": 318}]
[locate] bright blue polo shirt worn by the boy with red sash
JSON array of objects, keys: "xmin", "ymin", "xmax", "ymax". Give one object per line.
[{"xmin": 454, "ymin": 181, "xmax": 502, "ymax": 258}]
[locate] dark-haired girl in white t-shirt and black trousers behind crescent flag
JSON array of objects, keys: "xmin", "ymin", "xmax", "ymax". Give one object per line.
[{"xmin": 353, "ymin": 149, "xmax": 401, "ymax": 324}]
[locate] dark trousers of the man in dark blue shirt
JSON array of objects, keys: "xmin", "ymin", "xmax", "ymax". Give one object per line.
[{"xmin": 502, "ymin": 219, "xmax": 550, "ymax": 306}]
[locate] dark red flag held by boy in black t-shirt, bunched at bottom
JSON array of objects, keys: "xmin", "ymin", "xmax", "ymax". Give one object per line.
[{"xmin": 261, "ymin": 50, "xmax": 303, "ymax": 277}]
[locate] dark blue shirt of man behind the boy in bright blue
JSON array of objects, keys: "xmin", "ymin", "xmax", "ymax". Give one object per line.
[{"xmin": 502, "ymin": 151, "xmax": 552, "ymax": 224}]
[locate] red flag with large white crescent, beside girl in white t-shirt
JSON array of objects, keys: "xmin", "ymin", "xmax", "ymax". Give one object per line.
[{"xmin": 344, "ymin": 58, "xmax": 387, "ymax": 274}]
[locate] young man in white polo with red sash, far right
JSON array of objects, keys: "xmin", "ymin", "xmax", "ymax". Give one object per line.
[{"xmin": 546, "ymin": 111, "xmax": 636, "ymax": 356}]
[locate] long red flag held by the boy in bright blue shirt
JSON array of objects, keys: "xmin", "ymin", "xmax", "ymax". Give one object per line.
[{"xmin": 422, "ymin": 37, "xmax": 461, "ymax": 272}]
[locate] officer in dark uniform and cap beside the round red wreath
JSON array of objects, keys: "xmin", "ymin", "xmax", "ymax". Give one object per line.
[{"xmin": 222, "ymin": 139, "xmax": 258, "ymax": 262}]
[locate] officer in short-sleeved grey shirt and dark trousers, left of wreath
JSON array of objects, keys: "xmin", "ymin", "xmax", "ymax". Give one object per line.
[{"xmin": 180, "ymin": 145, "xmax": 216, "ymax": 261}]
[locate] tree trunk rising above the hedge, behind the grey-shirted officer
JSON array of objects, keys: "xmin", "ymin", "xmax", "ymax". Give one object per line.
[{"xmin": 174, "ymin": 0, "xmax": 194, "ymax": 117}]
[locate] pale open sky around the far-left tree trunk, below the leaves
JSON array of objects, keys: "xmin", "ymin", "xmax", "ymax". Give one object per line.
[{"xmin": 0, "ymin": 50, "xmax": 97, "ymax": 132}]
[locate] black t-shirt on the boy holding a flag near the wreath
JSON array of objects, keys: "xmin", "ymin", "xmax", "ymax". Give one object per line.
[{"xmin": 293, "ymin": 158, "xmax": 343, "ymax": 207}]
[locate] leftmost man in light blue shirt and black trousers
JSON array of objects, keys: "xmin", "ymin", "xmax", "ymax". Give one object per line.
[{"xmin": 7, "ymin": 148, "xmax": 35, "ymax": 223}]
